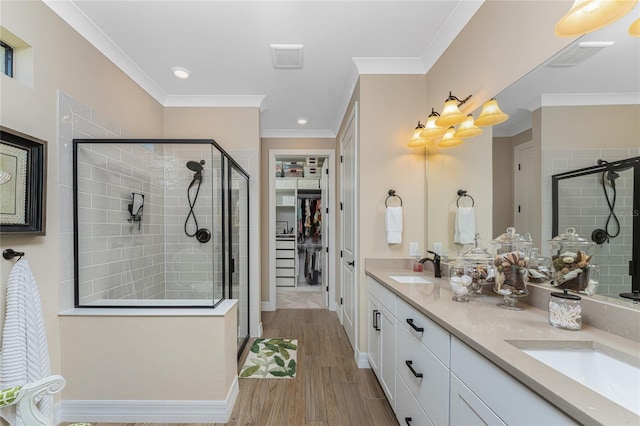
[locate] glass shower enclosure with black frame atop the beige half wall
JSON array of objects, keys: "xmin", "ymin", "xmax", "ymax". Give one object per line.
[{"xmin": 73, "ymin": 139, "xmax": 249, "ymax": 349}]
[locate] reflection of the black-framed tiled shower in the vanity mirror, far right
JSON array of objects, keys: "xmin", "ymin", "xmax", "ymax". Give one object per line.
[{"xmin": 552, "ymin": 157, "xmax": 640, "ymax": 297}]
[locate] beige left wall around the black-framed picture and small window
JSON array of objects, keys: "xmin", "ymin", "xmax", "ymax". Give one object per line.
[{"xmin": 0, "ymin": 1, "xmax": 162, "ymax": 386}]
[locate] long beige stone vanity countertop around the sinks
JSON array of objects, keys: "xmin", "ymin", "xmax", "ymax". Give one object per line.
[{"xmin": 366, "ymin": 261, "xmax": 640, "ymax": 426}]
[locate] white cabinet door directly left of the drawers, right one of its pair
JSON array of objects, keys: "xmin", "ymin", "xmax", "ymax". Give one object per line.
[{"xmin": 378, "ymin": 304, "xmax": 396, "ymax": 408}]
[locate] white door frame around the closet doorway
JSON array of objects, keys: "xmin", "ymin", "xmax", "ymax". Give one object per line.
[{"xmin": 262, "ymin": 148, "xmax": 338, "ymax": 311}]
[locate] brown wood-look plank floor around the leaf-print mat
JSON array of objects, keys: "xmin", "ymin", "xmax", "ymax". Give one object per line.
[{"xmin": 78, "ymin": 309, "xmax": 398, "ymax": 426}]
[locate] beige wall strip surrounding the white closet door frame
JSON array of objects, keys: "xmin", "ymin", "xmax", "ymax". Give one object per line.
[{"xmin": 260, "ymin": 138, "xmax": 339, "ymax": 302}]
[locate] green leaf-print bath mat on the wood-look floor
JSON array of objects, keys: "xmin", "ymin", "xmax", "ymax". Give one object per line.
[{"xmin": 240, "ymin": 339, "xmax": 298, "ymax": 379}]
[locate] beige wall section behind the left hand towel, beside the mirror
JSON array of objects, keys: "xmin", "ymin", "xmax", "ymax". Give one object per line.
[{"xmin": 357, "ymin": 75, "xmax": 427, "ymax": 350}]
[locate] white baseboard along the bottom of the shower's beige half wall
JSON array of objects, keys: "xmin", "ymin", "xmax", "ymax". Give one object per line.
[{"xmin": 60, "ymin": 376, "xmax": 239, "ymax": 423}]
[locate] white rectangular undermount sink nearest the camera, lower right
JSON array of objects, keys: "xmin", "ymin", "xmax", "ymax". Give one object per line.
[{"xmin": 509, "ymin": 341, "xmax": 640, "ymax": 416}]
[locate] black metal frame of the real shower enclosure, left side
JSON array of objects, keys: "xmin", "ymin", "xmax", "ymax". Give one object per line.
[{"xmin": 73, "ymin": 139, "xmax": 251, "ymax": 312}]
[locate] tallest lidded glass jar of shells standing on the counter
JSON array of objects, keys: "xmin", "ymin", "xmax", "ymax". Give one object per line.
[{"xmin": 491, "ymin": 227, "xmax": 532, "ymax": 310}]
